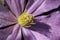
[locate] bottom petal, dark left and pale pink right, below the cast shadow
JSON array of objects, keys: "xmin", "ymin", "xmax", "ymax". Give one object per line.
[{"xmin": 23, "ymin": 28, "xmax": 49, "ymax": 40}]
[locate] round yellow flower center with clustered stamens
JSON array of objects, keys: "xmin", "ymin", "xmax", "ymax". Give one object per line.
[{"xmin": 18, "ymin": 11, "xmax": 34, "ymax": 27}]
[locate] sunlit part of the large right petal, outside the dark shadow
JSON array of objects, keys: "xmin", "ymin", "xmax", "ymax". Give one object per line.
[{"xmin": 37, "ymin": 11, "xmax": 60, "ymax": 40}]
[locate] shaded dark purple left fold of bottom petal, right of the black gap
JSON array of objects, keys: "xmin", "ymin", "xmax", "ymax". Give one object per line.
[{"xmin": 22, "ymin": 28, "xmax": 36, "ymax": 40}]
